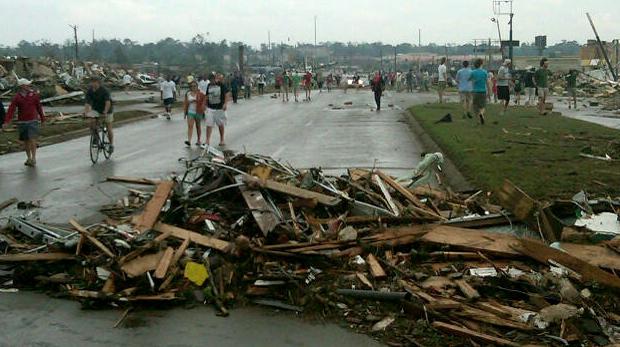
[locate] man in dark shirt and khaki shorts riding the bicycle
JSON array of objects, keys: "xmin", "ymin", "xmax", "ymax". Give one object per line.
[{"xmin": 84, "ymin": 76, "xmax": 114, "ymax": 153}]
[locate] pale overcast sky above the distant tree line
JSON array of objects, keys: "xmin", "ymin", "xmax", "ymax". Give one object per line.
[{"xmin": 0, "ymin": 0, "xmax": 620, "ymax": 46}]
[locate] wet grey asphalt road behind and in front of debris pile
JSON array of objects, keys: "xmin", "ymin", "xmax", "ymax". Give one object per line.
[{"xmin": 0, "ymin": 91, "xmax": 435, "ymax": 347}]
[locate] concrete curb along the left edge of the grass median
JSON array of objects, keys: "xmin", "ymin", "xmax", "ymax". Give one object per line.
[{"xmin": 405, "ymin": 109, "xmax": 476, "ymax": 192}]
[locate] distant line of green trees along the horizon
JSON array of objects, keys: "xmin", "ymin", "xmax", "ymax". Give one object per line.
[{"xmin": 0, "ymin": 35, "xmax": 580, "ymax": 70}]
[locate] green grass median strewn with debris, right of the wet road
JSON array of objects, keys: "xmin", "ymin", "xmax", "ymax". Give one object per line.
[{"xmin": 409, "ymin": 103, "xmax": 620, "ymax": 199}]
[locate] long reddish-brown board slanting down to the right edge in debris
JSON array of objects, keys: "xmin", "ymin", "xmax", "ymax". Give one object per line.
[{"xmin": 513, "ymin": 239, "xmax": 620, "ymax": 289}]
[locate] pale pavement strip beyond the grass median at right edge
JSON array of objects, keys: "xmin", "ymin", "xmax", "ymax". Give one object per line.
[{"xmin": 550, "ymin": 97, "xmax": 620, "ymax": 129}]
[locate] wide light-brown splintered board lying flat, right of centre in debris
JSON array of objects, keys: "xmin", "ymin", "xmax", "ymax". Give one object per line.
[{"xmin": 420, "ymin": 225, "xmax": 520, "ymax": 257}]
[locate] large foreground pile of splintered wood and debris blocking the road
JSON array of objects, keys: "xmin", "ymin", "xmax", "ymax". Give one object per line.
[{"xmin": 0, "ymin": 149, "xmax": 620, "ymax": 346}]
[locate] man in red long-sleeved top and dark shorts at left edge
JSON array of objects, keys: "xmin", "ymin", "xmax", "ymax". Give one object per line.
[{"xmin": 2, "ymin": 78, "xmax": 45, "ymax": 167}]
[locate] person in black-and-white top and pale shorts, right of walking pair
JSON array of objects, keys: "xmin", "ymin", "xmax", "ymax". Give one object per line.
[{"xmin": 206, "ymin": 74, "xmax": 231, "ymax": 147}]
